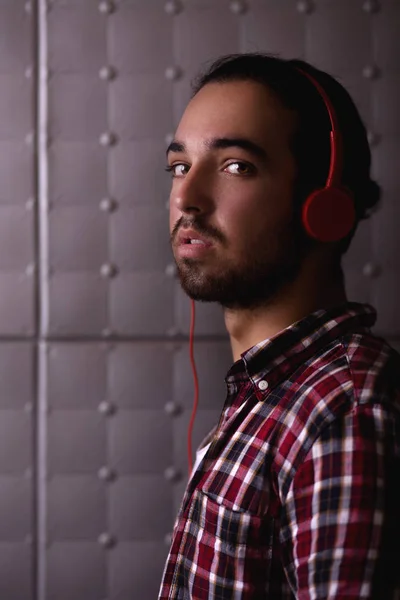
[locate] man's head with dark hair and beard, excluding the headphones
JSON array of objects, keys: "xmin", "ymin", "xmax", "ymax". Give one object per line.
[{"xmin": 168, "ymin": 54, "xmax": 379, "ymax": 308}]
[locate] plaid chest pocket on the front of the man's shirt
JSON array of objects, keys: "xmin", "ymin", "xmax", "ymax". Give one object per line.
[{"xmin": 181, "ymin": 490, "xmax": 274, "ymax": 600}]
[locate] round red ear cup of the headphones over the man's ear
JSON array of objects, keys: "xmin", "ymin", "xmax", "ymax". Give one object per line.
[{"xmin": 302, "ymin": 187, "xmax": 356, "ymax": 242}]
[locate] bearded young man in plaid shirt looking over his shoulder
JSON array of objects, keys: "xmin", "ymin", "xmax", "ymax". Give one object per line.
[{"xmin": 159, "ymin": 55, "xmax": 400, "ymax": 600}]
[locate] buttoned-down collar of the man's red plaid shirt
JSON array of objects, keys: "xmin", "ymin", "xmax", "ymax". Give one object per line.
[{"xmin": 226, "ymin": 302, "xmax": 377, "ymax": 400}]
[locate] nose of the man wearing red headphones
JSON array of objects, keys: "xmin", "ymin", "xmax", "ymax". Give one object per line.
[{"xmin": 171, "ymin": 168, "xmax": 213, "ymax": 214}]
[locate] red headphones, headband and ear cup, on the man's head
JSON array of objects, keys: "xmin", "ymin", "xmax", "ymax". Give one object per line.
[{"xmin": 296, "ymin": 67, "xmax": 356, "ymax": 242}]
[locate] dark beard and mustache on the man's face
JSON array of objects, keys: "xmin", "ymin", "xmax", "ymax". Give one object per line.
[{"xmin": 171, "ymin": 219, "xmax": 308, "ymax": 309}]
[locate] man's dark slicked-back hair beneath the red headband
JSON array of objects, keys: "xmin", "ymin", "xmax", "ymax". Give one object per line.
[{"xmin": 192, "ymin": 53, "xmax": 381, "ymax": 255}]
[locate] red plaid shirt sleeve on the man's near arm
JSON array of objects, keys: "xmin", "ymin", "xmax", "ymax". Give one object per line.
[{"xmin": 280, "ymin": 404, "xmax": 400, "ymax": 600}]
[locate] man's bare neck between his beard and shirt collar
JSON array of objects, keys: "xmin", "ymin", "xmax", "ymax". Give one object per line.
[{"xmin": 225, "ymin": 270, "xmax": 347, "ymax": 361}]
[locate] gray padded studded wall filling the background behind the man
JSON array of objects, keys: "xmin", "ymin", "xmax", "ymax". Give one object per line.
[{"xmin": 0, "ymin": 0, "xmax": 400, "ymax": 600}]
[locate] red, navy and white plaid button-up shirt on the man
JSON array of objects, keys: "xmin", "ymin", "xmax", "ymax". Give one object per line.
[{"xmin": 159, "ymin": 302, "xmax": 400, "ymax": 600}]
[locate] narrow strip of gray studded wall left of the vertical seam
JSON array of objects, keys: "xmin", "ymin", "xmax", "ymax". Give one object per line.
[{"xmin": 0, "ymin": 0, "xmax": 37, "ymax": 600}]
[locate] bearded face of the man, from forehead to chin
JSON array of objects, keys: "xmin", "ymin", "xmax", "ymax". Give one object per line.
[{"xmin": 168, "ymin": 81, "xmax": 301, "ymax": 308}]
